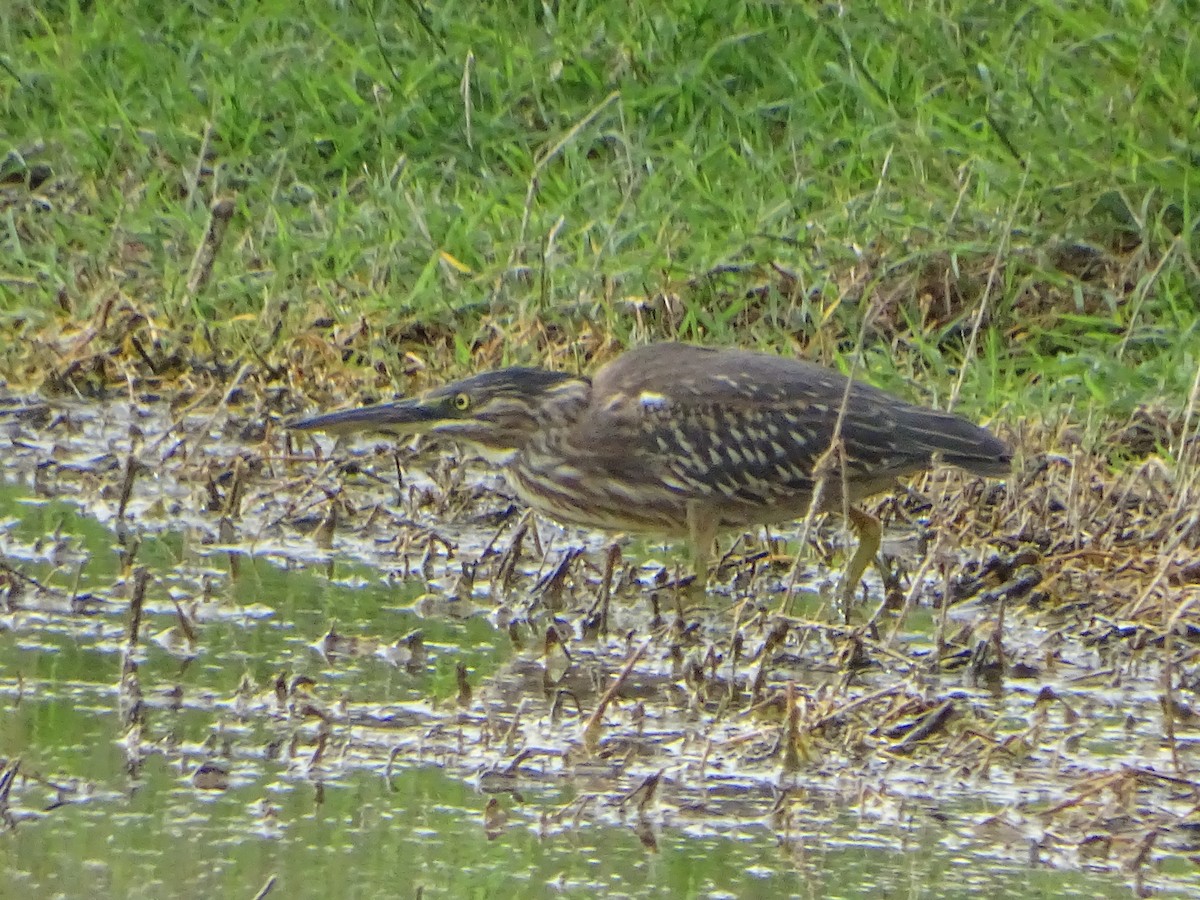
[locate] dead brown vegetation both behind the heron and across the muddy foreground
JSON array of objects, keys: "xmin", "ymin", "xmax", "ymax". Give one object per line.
[{"xmin": 0, "ymin": 154, "xmax": 1200, "ymax": 890}]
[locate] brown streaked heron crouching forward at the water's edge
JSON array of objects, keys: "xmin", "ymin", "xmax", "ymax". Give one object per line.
[{"xmin": 290, "ymin": 343, "xmax": 1012, "ymax": 600}]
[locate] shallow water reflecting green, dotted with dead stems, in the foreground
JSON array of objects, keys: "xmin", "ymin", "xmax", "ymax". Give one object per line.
[{"xmin": 0, "ymin": 407, "xmax": 1200, "ymax": 898}]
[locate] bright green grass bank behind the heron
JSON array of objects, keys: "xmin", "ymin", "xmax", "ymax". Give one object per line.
[{"xmin": 0, "ymin": 0, "xmax": 1200, "ymax": 429}]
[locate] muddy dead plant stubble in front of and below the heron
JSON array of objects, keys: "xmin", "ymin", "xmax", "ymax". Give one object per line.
[{"xmin": 0, "ymin": 374, "xmax": 1200, "ymax": 886}]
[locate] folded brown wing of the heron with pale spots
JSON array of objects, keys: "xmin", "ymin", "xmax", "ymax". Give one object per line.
[{"xmin": 575, "ymin": 344, "xmax": 1003, "ymax": 503}]
